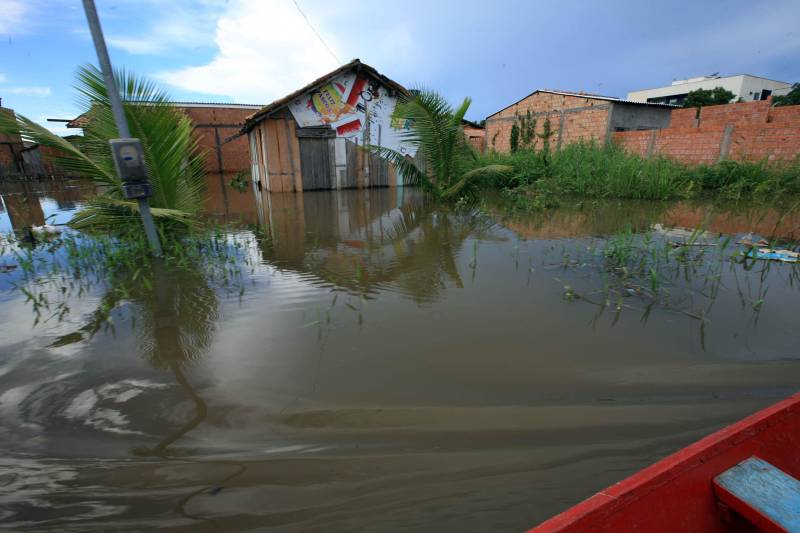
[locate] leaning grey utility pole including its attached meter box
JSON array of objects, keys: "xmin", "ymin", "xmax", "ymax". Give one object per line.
[{"xmin": 83, "ymin": 0, "xmax": 161, "ymax": 257}]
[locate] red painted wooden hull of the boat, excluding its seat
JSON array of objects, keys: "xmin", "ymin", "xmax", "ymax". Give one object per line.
[{"xmin": 529, "ymin": 394, "xmax": 800, "ymax": 533}]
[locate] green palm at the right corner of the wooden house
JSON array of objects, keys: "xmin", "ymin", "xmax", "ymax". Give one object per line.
[{"xmin": 366, "ymin": 90, "xmax": 511, "ymax": 200}]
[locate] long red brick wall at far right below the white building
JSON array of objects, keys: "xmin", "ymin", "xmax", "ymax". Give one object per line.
[{"xmin": 613, "ymin": 101, "xmax": 800, "ymax": 164}]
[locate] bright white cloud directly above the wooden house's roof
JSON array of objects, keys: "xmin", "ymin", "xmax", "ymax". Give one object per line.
[{"xmin": 157, "ymin": 0, "xmax": 337, "ymax": 103}]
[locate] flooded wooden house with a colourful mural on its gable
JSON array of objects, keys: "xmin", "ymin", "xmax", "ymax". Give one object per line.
[{"xmin": 242, "ymin": 59, "xmax": 416, "ymax": 192}]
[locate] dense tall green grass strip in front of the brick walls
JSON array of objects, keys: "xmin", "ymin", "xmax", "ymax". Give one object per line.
[{"xmin": 479, "ymin": 143, "xmax": 800, "ymax": 204}]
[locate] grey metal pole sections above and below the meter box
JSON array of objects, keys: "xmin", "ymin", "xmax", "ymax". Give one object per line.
[{"xmin": 83, "ymin": 0, "xmax": 161, "ymax": 257}]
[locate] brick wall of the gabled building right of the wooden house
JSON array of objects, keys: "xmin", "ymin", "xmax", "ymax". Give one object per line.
[{"xmin": 486, "ymin": 92, "xmax": 611, "ymax": 153}]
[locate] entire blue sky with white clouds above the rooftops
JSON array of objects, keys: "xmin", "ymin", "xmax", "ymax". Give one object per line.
[{"xmin": 0, "ymin": 0, "xmax": 800, "ymax": 133}]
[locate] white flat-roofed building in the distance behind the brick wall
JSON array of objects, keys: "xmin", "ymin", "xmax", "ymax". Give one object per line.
[{"xmin": 628, "ymin": 74, "xmax": 792, "ymax": 105}]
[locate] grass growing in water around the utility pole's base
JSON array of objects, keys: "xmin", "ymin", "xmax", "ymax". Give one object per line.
[{"xmin": 0, "ymin": 227, "xmax": 255, "ymax": 336}]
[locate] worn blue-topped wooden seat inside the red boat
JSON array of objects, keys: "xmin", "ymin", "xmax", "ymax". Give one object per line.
[{"xmin": 714, "ymin": 457, "xmax": 800, "ymax": 532}]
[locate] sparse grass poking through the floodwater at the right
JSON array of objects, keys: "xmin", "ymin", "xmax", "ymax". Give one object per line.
[{"xmin": 546, "ymin": 223, "xmax": 800, "ymax": 347}]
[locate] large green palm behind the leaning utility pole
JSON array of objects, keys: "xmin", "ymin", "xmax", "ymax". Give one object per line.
[{"xmin": 0, "ymin": 66, "xmax": 204, "ymax": 231}]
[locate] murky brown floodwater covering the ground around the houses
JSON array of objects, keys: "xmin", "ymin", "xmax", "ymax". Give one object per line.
[{"xmin": 0, "ymin": 178, "xmax": 800, "ymax": 532}]
